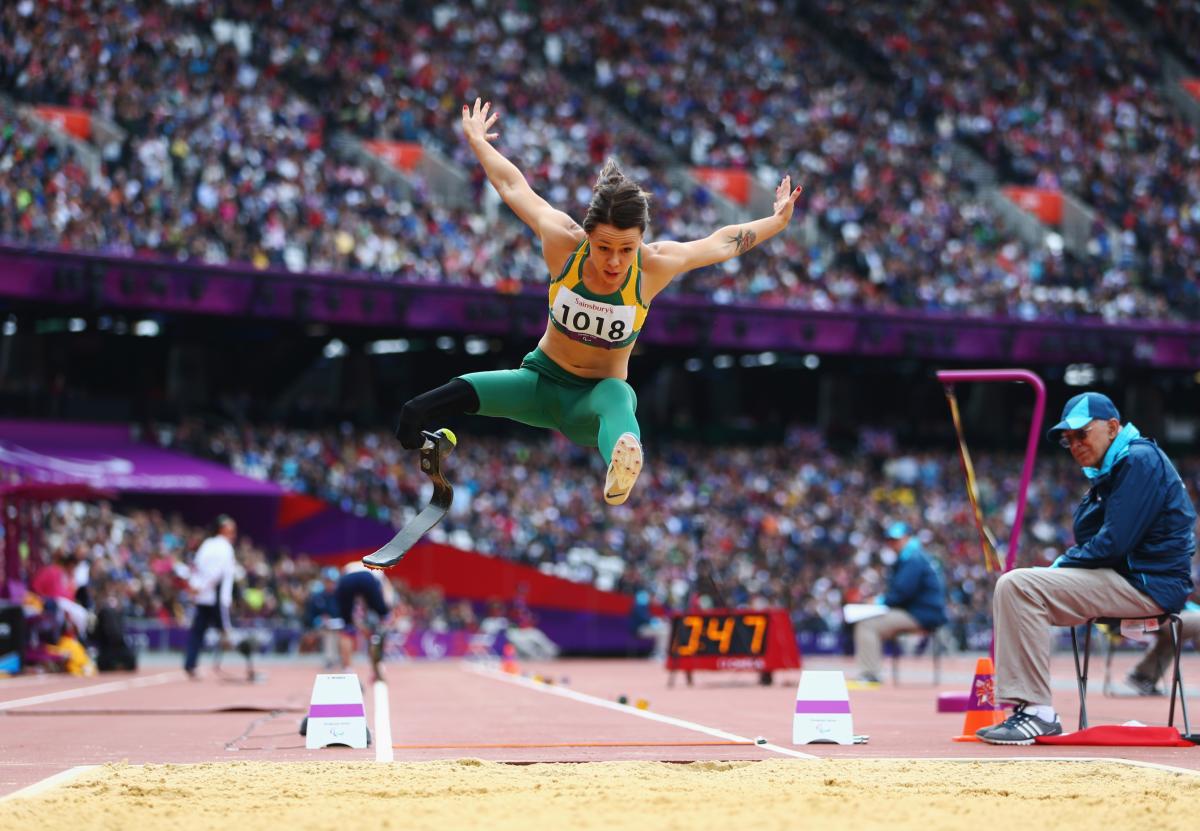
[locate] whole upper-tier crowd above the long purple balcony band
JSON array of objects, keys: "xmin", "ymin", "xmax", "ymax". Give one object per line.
[{"xmin": 0, "ymin": 0, "xmax": 1200, "ymax": 319}]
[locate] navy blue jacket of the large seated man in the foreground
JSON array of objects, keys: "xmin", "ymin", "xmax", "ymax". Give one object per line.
[{"xmin": 1055, "ymin": 438, "xmax": 1196, "ymax": 611}]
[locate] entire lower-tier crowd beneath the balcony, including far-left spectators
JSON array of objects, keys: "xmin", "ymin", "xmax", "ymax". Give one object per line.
[{"xmin": 9, "ymin": 415, "xmax": 1200, "ymax": 667}]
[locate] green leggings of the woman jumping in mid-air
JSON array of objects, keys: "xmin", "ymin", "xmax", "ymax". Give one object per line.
[{"xmin": 458, "ymin": 349, "xmax": 642, "ymax": 464}]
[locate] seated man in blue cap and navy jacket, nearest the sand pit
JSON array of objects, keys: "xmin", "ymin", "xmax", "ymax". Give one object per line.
[{"xmin": 976, "ymin": 393, "xmax": 1196, "ymax": 745}]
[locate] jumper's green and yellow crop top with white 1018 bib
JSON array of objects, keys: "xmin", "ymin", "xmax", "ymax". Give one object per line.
[{"xmin": 550, "ymin": 239, "xmax": 650, "ymax": 349}]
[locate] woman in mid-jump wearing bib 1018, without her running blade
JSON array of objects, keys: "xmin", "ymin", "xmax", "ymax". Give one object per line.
[{"xmin": 396, "ymin": 98, "xmax": 802, "ymax": 504}]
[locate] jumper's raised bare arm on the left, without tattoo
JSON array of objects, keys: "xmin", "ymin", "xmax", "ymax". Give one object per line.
[{"xmin": 462, "ymin": 98, "xmax": 583, "ymax": 246}]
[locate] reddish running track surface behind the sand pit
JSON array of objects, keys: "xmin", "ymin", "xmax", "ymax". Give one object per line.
[{"xmin": 0, "ymin": 653, "xmax": 1200, "ymax": 795}]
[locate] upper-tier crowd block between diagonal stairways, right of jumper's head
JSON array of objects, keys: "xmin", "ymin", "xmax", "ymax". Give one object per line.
[{"xmin": 540, "ymin": 2, "xmax": 1113, "ymax": 317}]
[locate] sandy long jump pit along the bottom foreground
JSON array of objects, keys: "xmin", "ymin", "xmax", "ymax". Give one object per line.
[{"xmin": 0, "ymin": 759, "xmax": 1200, "ymax": 831}]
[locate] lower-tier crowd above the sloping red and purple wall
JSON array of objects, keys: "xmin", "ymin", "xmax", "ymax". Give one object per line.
[{"xmin": 164, "ymin": 424, "xmax": 1200, "ymax": 638}]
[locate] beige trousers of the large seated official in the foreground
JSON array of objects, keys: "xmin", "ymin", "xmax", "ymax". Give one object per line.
[{"xmin": 992, "ymin": 568, "xmax": 1163, "ymax": 704}]
